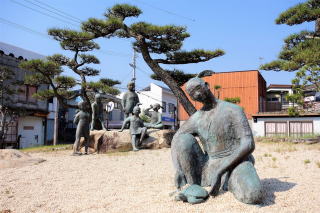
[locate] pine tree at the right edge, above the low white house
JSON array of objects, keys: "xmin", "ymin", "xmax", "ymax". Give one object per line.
[{"xmin": 260, "ymin": 0, "xmax": 320, "ymax": 100}]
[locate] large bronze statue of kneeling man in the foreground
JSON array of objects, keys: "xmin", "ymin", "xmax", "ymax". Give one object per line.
[{"xmin": 171, "ymin": 71, "xmax": 263, "ymax": 204}]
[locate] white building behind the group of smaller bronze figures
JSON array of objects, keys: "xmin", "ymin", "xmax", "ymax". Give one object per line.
[{"xmin": 119, "ymin": 83, "xmax": 177, "ymax": 129}]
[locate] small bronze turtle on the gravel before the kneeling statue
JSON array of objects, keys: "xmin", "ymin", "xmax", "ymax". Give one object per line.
[{"xmin": 175, "ymin": 185, "xmax": 209, "ymax": 204}]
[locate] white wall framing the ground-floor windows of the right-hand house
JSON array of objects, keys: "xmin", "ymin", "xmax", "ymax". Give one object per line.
[{"xmin": 252, "ymin": 117, "xmax": 320, "ymax": 137}]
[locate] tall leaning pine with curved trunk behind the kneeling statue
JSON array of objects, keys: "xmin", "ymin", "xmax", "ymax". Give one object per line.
[{"xmin": 82, "ymin": 4, "xmax": 225, "ymax": 115}]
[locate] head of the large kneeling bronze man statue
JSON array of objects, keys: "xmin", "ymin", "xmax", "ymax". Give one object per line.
[{"xmin": 186, "ymin": 77, "xmax": 210, "ymax": 102}]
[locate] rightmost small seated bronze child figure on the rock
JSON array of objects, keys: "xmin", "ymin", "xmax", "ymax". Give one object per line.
[{"xmin": 143, "ymin": 103, "xmax": 163, "ymax": 129}]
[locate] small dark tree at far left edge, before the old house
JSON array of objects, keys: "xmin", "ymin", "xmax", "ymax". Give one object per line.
[{"xmin": 0, "ymin": 66, "xmax": 23, "ymax": 149}]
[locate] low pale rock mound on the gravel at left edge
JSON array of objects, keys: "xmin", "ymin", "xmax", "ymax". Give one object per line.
[{"xmin": 0, "ymin": 149, "xmax": 45, "ymax": 169}]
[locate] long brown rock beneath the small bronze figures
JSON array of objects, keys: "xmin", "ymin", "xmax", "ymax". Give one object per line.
[{"xmin": 79, "ymin": 129, "xmax": 176, "ymax": 153}]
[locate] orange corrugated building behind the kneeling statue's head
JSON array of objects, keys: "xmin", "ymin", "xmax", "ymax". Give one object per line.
[{"xmin": 178, "ymin": 70, "xmax": 267, "ymax": 124}]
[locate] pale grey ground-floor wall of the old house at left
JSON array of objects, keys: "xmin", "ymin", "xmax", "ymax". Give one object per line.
[{"xmin": 18, "ymin": 116, "xmax": 44, "ymax": 148}]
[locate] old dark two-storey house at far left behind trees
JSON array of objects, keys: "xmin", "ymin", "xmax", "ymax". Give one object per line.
[{"xmin": 0, "ymin": 42, "xmax": 50, "ymax": 148}]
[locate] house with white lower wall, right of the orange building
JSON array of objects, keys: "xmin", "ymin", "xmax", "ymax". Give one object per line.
[{"xmin": 252, "ymin": 84, "xmax": 320, "ymax": 137}]
